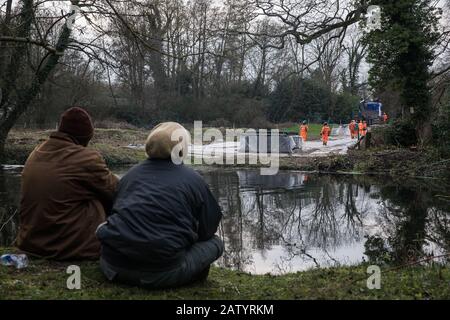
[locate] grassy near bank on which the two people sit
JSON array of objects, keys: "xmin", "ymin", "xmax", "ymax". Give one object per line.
[{"xmin": 0, "ymin": 248, "xmax": 450, "ymax": 300}]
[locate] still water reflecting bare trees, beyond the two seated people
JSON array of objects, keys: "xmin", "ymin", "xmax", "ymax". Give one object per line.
[{"xmin": 0, "ymin": 168, "xmax": 450, "ymax": 274}]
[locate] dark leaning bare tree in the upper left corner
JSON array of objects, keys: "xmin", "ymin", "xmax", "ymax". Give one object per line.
[{"xmin": 0, "ymin": 0, "xmax": 79, "ymax": 155}]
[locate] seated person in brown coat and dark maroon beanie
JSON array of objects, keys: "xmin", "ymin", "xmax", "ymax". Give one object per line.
[{"xmin": 16, "ymin": 107, "xmax": 118, "ymax": 260}]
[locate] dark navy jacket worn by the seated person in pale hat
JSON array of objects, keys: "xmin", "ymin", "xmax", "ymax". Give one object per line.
[{"xmin": 99, "ymin": 160, "xmax": 222, "ymax": 271}]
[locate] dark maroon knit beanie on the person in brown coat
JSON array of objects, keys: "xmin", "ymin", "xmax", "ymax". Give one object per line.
[{"xmin": 58, "ymin": 107, "xmax": 94, "ymax": 146}]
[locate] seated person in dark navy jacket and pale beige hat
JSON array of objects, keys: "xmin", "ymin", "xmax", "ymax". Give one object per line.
[{"xmin": 96, "ymin": 122, "xmax": 223, "ymax": 288}]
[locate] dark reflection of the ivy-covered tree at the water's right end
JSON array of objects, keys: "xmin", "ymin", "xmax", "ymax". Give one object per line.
[{"xmin": 366, "ymin": 181, "xmax": 450, "ymax": 263}]
